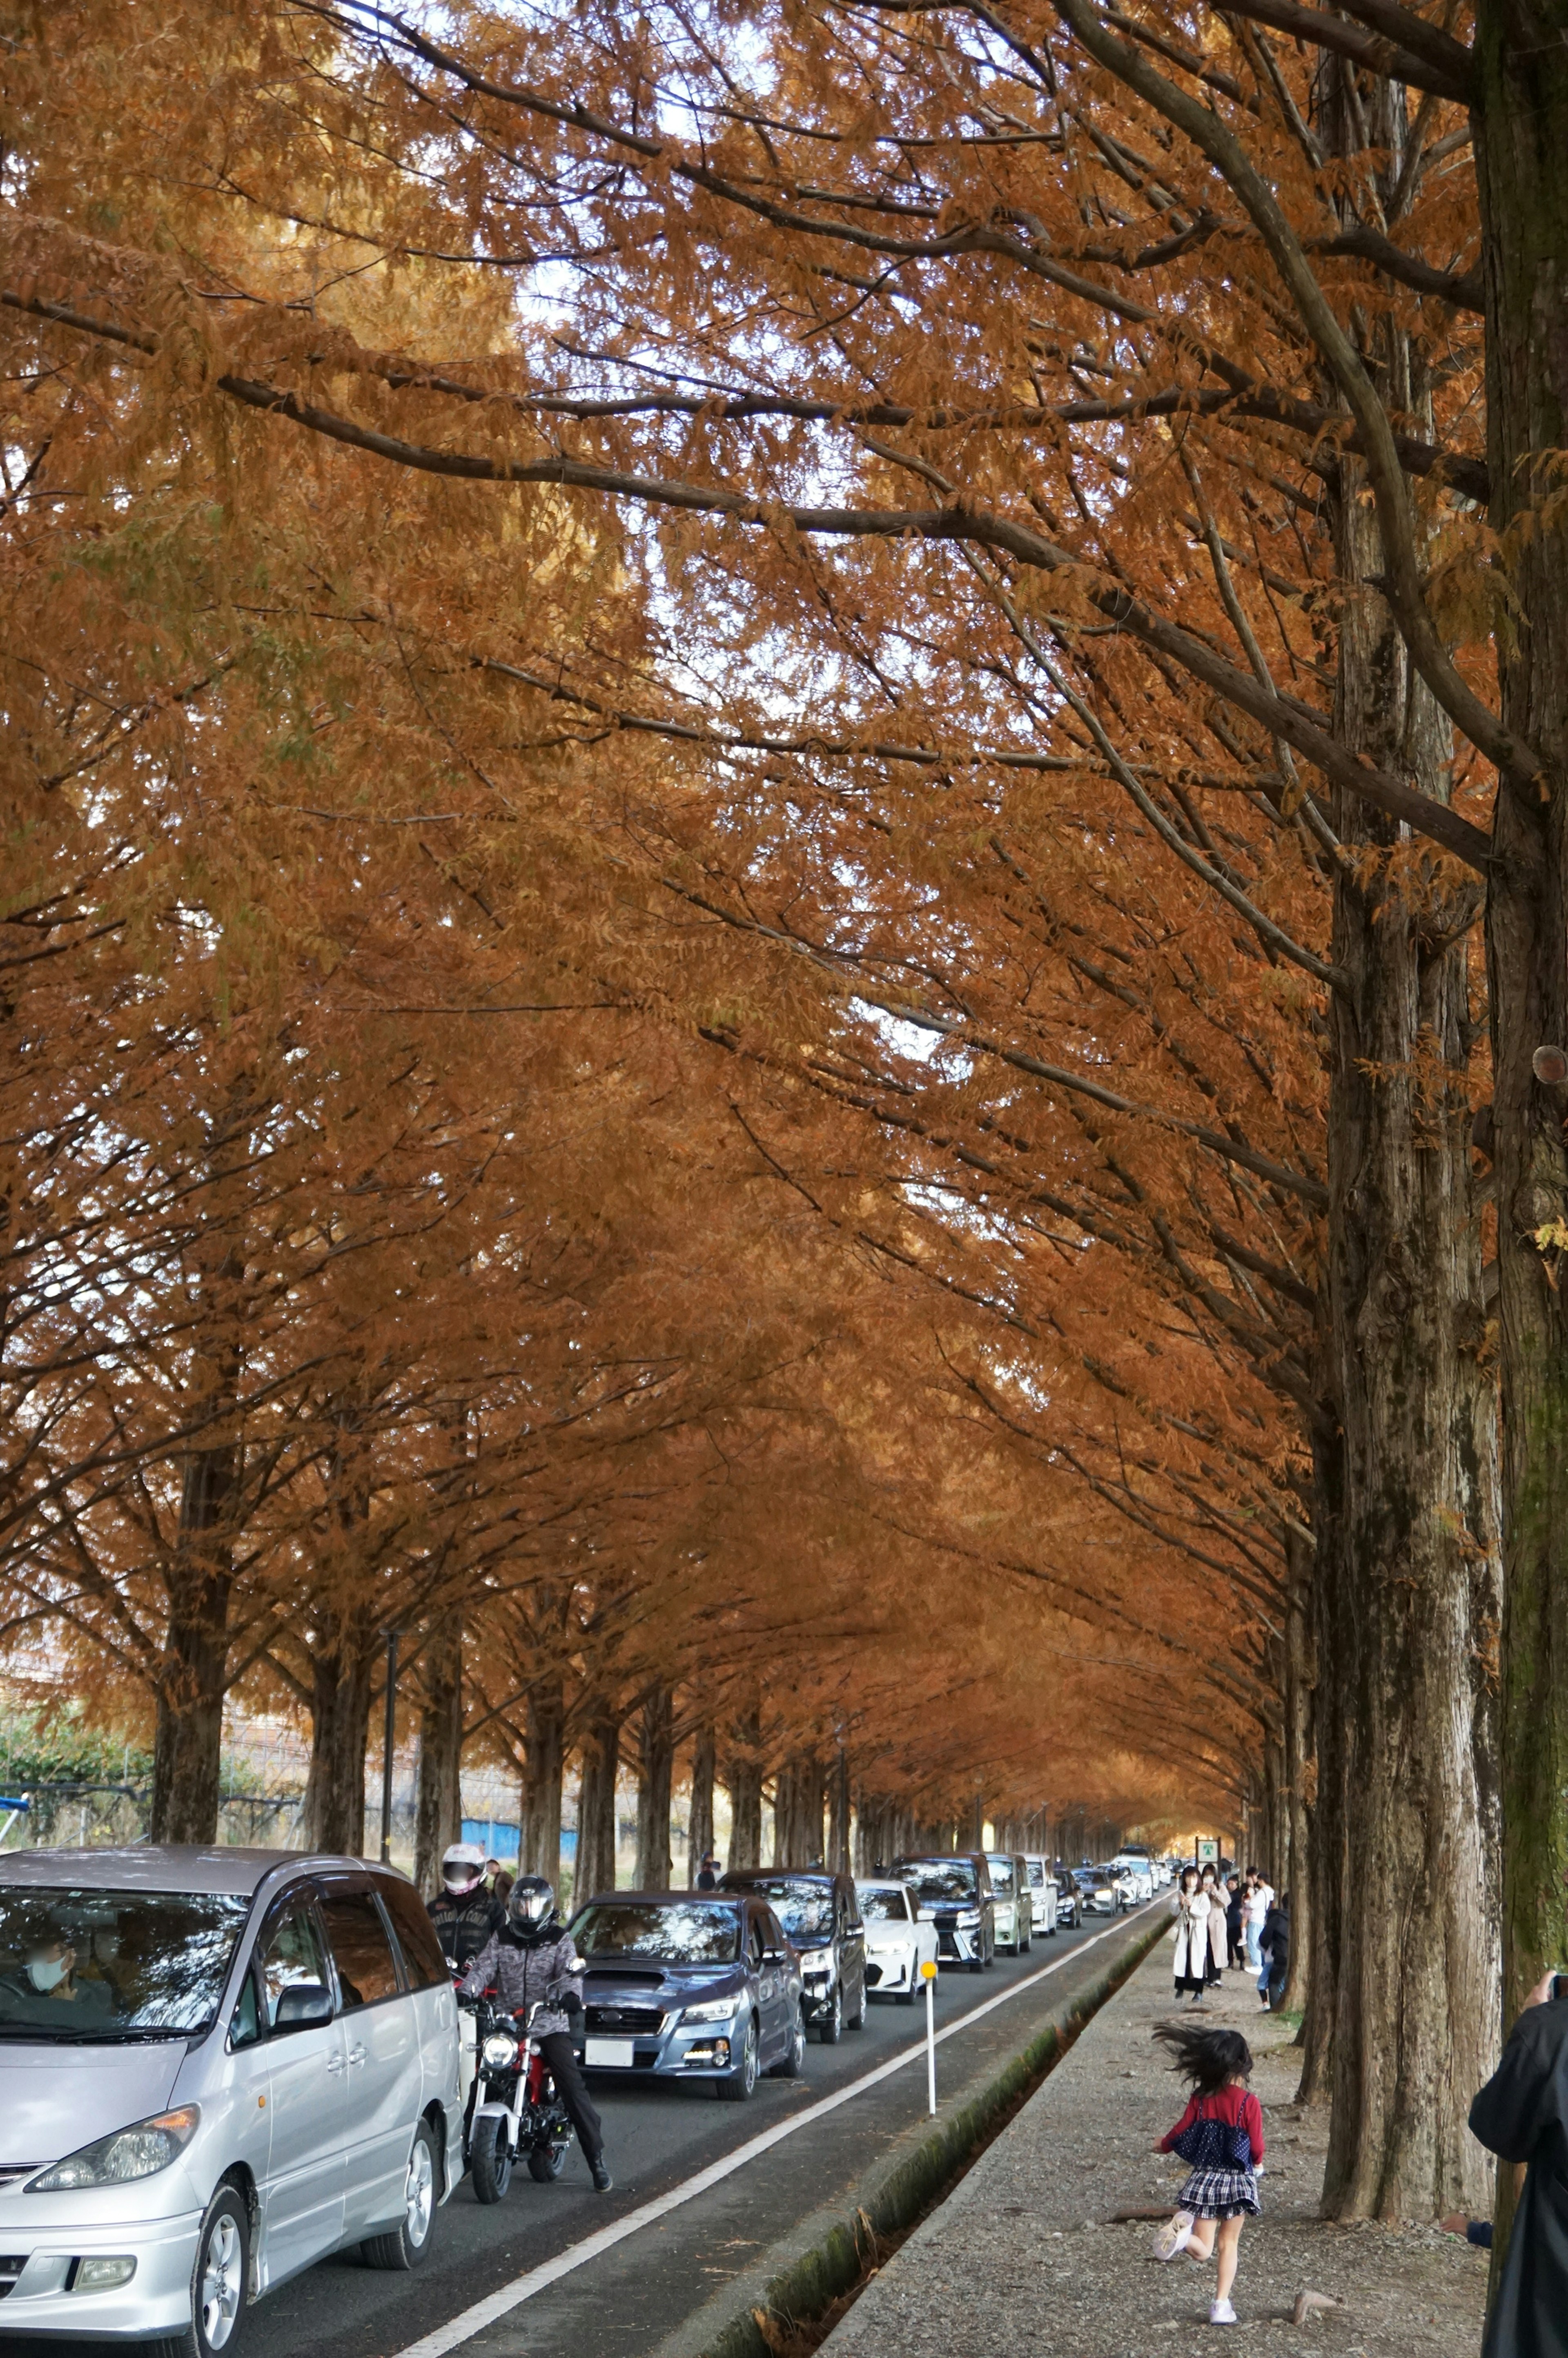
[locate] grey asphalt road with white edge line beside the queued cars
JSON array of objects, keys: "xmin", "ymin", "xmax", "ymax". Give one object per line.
[{"xmin": 0, "ymin": 1913, "xmax": 1160, "ymax": 2358}]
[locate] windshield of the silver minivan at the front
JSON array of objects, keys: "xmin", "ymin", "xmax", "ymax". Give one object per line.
[{"xmin": 0, "ymin": 1884, "xmax": 250, "ymax": 2044}]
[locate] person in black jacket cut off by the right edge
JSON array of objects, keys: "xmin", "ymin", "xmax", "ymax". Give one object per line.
[{"xmin": 1469, "ymin": 1974, "xmax": 1568, "ymax": 2358}]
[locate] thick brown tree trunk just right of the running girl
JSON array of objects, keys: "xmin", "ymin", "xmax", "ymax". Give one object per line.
[{"xmin": 1318, "ymin": 429, "xmax": 1500, "ymax": 2219}]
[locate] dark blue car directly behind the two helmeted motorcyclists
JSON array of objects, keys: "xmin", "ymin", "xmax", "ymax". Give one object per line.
[{"xmin": 570, "ymin": 1891, "xmax": 806, "ymax": 2101}]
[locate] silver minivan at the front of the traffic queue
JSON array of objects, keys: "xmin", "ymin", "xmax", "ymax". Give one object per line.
[{"xmin": 0, "ymin": 1849, "xmax": 462, "ymax": 2358}]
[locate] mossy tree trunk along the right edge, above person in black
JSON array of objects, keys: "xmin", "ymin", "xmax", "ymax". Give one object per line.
[{"xmin": 1474, "ymin": 0, "xmax": 1568, "ymax": 2266}]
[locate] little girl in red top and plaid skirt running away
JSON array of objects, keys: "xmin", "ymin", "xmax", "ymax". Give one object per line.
[{"xmin": 1155, "ymin": 2023, "xmax": 1264, "ymax": 2325}]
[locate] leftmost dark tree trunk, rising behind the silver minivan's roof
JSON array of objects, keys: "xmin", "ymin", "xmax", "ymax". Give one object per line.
[{"xmin": 151, "ymin": 1441, "xmax": 241, "ymax": 1844}]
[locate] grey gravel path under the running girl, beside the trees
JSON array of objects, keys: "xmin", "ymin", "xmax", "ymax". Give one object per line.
[{"xmin": 823, "ymin": 1943, "xmax": 1488, "ymax": 2358}]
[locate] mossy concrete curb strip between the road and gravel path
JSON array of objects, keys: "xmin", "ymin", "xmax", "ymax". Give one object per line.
[{"xmin": 655, "ymin": 1910, "xmax": 1169, "ymax": 2358}]
